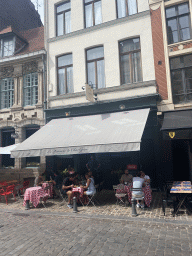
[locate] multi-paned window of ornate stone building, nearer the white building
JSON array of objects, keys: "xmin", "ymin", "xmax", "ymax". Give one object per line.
[{"xmin": 24, "ymin": 73, "xmax": 38, "ymax": 106}]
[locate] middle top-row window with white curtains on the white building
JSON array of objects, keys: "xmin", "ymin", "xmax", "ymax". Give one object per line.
[{"xmin": 84, "ymin": 0, "xmax": 102, "ymax": 28}]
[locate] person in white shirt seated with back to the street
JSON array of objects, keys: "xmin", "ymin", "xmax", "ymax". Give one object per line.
[{"xmin": 132, "ymin": 172, "xmax": 145, "ymax": 208}]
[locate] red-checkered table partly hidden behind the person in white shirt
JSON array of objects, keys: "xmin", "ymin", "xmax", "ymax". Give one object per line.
[{"xmin": 117, "ymin": 183, "xmax": 152, "ymax": 207}]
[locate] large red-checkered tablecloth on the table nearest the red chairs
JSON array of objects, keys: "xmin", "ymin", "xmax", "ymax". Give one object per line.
[{"xmin": 23, "ymin": 187, "xmax": 49, "ymax": 207}]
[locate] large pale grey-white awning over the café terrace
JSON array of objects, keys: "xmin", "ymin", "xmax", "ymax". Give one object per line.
[{"xmin": 11, "ymin": 109, "xmax": 150, "ymax": 158}]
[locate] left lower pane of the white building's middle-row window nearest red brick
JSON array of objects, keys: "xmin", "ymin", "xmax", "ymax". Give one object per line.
[{"xmin": 121, "ymin": 54, "xmax": 131, "ymax": 84}]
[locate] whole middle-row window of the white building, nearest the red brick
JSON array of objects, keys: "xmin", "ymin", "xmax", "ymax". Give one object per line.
[{"xmin": 119, "ymin": 38, "xmax": 142, "ymax": 84}]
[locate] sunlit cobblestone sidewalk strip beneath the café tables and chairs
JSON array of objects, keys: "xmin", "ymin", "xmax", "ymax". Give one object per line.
[{"xmin": 0, "ymin": 190, "xmax": 192, "ymax": 221}]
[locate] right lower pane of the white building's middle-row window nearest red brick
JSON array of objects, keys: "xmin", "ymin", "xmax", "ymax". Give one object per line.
[{"xmin": 132, "ymin": 52, "xmax": 142, "ymax": 83}]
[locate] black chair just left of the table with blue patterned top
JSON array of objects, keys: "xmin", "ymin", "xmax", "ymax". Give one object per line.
[{"xmin": 162, "ymin": 182, "xmax": 176, "ymax": 216}]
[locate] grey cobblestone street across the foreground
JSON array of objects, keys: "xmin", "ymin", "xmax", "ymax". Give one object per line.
[{"xmin": 0, "ymin": 210, "xmax": 192, "ymax": 256}]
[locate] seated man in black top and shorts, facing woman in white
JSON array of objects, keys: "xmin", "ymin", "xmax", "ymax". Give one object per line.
[{"xmin": 61, "ymin": 173, "xmax": 74, "ymax": 208}]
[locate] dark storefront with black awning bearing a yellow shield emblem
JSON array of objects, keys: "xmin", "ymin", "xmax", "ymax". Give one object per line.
[{"xmin": 161, "ymin": 110, "xmax": 192, "ymax": 181}]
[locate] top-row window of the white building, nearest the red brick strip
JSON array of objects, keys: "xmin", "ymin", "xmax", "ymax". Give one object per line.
[{"xmin": 116, "ymin": 0, "xmax": 137, "ymax": 18}]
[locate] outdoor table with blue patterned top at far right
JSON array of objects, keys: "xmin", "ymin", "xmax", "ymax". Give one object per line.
[{"xmin": 170, "ymin": 181, "xmax": 192, "ymax": 214}]
